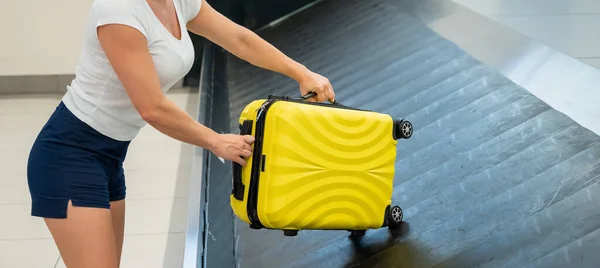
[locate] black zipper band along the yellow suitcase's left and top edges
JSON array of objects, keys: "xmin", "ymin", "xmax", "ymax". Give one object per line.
[{"xmin": 247, "ymin": 96, "xmax": 367, "ymax": 229}]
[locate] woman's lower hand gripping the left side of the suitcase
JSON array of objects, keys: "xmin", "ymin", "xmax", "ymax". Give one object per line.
[{"xmin": 212, "ymin": 134, "xmax": 254, "ymax": 166}]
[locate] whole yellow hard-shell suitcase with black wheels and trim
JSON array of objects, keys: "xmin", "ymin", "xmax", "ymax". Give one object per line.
[{"xmin": 230, "ymin": 96, "xmax": 413, "ymax": 236}]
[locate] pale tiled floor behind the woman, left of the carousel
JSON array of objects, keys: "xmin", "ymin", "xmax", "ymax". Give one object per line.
[{"xmin": 0, "ymin": 89, "xmax": 197, "ymax": 268}]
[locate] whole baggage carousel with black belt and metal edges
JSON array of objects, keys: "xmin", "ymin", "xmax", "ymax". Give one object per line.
[{"xmin": 184, "ymin": 0, "xmax": 600, "ymax": 268}]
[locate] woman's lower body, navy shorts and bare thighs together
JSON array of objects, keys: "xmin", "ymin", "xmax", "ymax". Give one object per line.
[{"xmin": 27, "ymin": 102, "xmax": 129, "ymax": 268}]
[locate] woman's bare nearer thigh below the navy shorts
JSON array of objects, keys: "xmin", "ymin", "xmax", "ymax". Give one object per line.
[{"xmin": 45, "ymin": 201, "xmax": 119, "ymax": 268}]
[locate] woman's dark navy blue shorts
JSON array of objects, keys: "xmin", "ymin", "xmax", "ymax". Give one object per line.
[{"xmin": 27, "ymin": 102, "xmax": 130, "ymax": 218}]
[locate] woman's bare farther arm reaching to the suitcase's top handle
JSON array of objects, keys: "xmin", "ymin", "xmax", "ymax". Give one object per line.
[{"xmin": 187, "ymin": 0, "xmax": 335, "ymax": 101}]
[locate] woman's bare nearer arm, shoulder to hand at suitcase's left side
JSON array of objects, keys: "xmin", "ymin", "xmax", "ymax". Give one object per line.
[{"xmin": 98, "ymin": 24, "xmax": 254, "ymax": 165}]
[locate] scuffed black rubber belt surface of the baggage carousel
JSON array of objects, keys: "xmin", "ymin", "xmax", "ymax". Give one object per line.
[{"xmin": 223, "ymin": 0, "xmax": 600, "ymax": 267}]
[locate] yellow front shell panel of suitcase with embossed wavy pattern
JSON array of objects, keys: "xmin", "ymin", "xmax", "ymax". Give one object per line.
[{"xmin": 259, "ymin": 103, "xmax": 396, "ymax": 229}]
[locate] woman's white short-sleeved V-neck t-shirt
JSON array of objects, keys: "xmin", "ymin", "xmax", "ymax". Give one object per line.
[{"xmin": 63, "ymin": 0, "xmax": 201, "ymax": 141}]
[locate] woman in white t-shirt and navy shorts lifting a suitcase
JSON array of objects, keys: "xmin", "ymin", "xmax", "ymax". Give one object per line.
[{"xmin": 28, "ymin": 0, "xmax": 334, "ymax": 268}]
